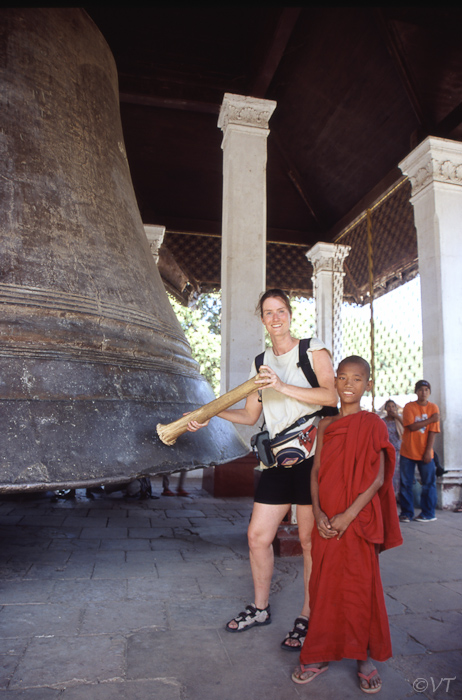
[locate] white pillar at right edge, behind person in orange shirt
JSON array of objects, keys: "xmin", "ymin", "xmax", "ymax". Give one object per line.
[{"xmin": 399, "ymin": 137, "xmax": 462, "ymax": 508}]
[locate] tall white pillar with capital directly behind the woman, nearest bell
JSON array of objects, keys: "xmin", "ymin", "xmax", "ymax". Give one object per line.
[{"xmin": 218, "ymin": 93, "xmax": 276, "ymax": 418}]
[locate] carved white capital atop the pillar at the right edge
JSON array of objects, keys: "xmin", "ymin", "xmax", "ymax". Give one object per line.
[{"xmin": 399, "ymin": 136, "xmax": 462, "ymax": 197}]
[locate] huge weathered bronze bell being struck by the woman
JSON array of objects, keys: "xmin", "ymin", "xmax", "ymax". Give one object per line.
[{"xmin": 0, "ymin": 8, "xmax": 248, "ymax": 492}]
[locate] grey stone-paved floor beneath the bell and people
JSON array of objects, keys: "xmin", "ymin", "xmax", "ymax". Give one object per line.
[{"xmin": 0, "ymin": 477, "xmax": 462, "ymax": 700}]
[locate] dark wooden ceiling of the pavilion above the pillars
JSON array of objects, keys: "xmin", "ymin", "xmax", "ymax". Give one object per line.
[{"xmin": 85, "ymin": 6, "xmax": 462, "ymax": 301}]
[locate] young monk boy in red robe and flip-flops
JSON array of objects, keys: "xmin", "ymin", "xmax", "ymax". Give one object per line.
[{"xmin": 292, "ymin": 356, "xmax": 403, "ymax": 693}]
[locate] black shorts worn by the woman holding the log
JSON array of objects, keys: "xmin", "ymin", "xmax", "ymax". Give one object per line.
[{"xmin": 254, "ymin": 457, "xmax": 314, "ymax": 506}]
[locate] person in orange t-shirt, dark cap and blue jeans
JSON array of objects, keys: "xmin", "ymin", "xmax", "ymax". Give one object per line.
[{"xmin": 399, "ymin": 379, "xmax": 440, "ymax": 523}]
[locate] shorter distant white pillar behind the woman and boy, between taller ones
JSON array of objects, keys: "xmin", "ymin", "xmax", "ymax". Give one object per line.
[{"xmin": 306, "ymin": 243, "xmax": 350, "ymax": 367}]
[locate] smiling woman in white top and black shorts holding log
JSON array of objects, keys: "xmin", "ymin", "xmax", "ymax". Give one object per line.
[{"xmin": 188, "ymin": 289, "xmax": 337, "ymax": 651}]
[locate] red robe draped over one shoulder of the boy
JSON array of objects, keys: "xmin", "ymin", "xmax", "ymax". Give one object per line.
[{"xmin": 300, "ymin": 411, "xmax": 403, "ymax": 664}]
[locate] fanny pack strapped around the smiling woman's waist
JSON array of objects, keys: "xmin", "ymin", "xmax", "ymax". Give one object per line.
[{"xmin": 250, "ymin": 411, "xmax": 320, "ymax": 467}]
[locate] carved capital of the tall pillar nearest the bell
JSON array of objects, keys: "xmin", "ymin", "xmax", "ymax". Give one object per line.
[{"xmin": 218, "ymin": 92, "xmax": 277, "ymax": 138}]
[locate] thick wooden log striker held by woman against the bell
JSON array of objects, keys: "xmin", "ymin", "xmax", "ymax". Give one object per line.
[{"xmin": 157, "ymin": 374, "xmax": 261, "ymax": 445}]
